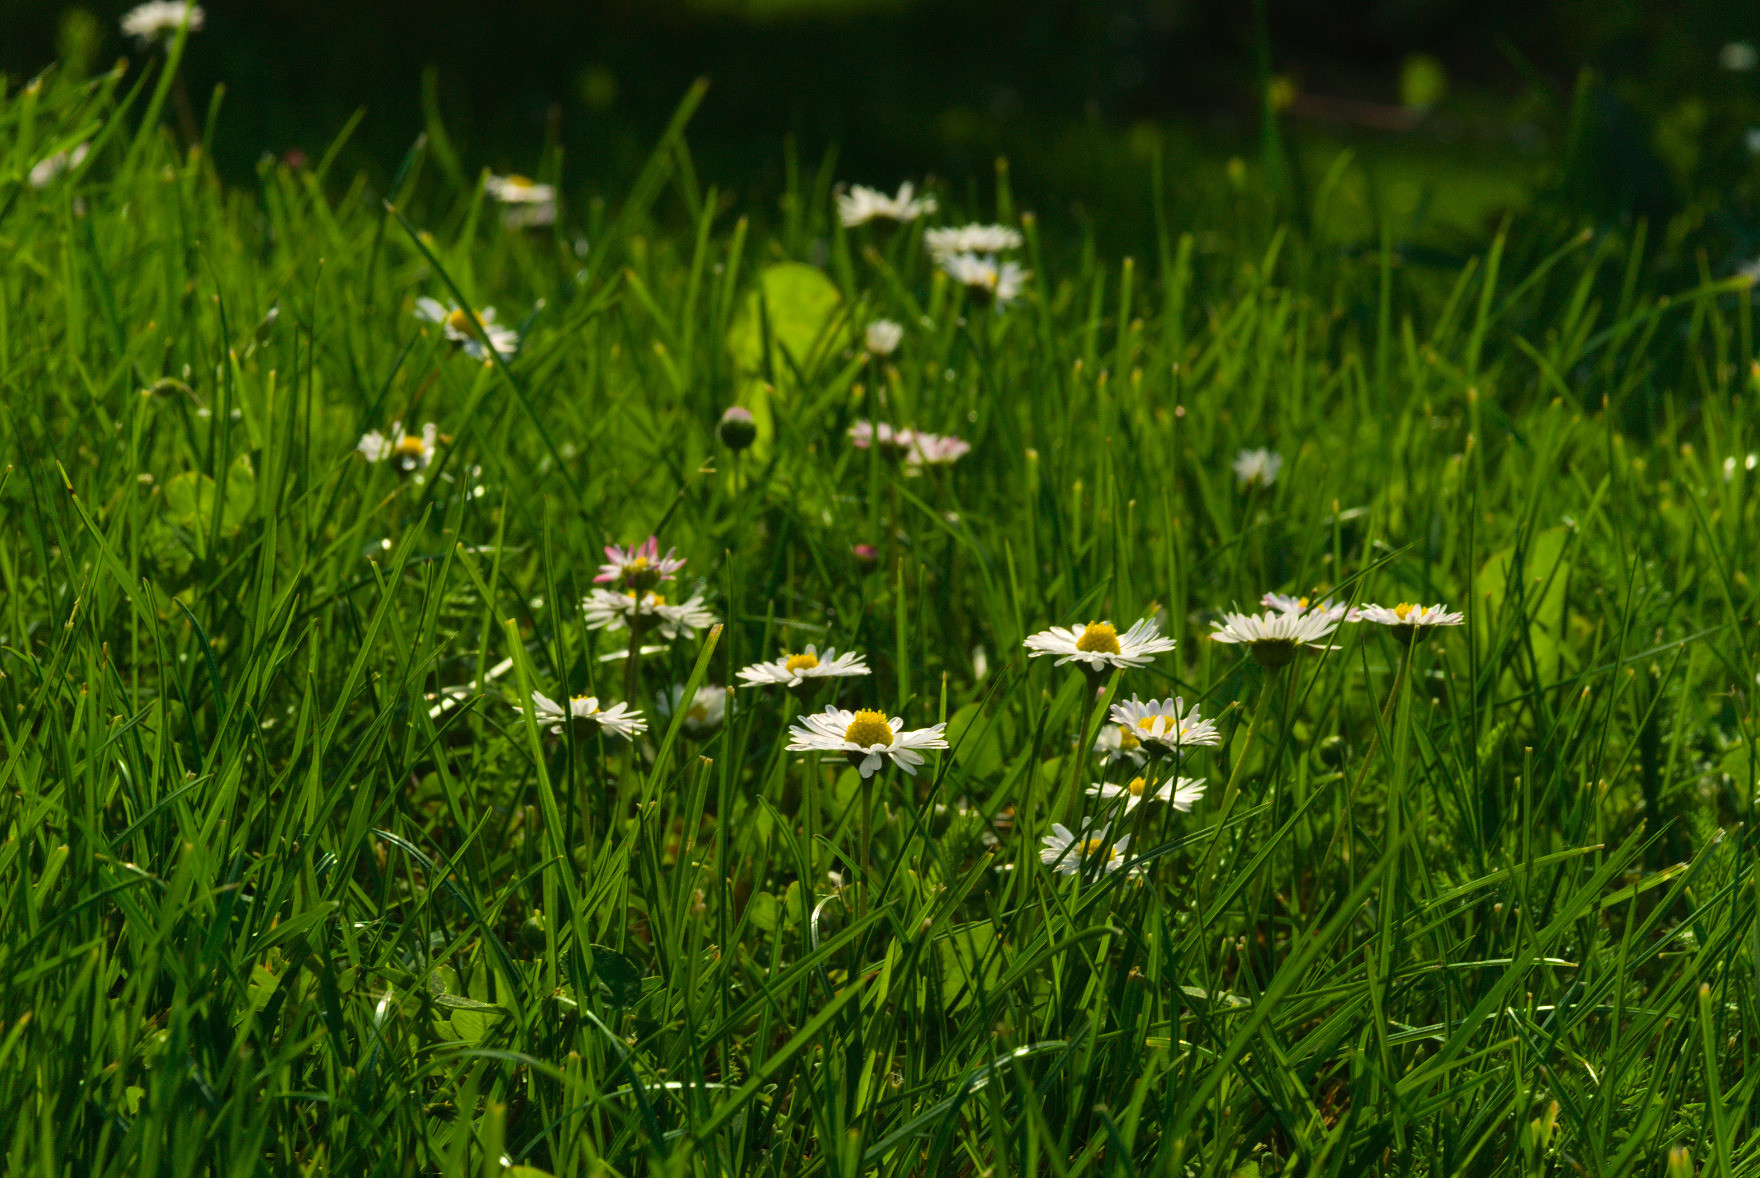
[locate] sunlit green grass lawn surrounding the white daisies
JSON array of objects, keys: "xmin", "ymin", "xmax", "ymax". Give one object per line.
[{"xmin": 0, "ymin": 48, "xmax": 1760, "ymax": 1178}]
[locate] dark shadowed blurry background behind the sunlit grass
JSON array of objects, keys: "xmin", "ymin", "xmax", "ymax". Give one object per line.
[{"xmin": 0, "ymin": 0, "xmax": 1760, "ymax": 264}]
